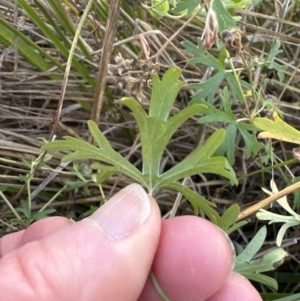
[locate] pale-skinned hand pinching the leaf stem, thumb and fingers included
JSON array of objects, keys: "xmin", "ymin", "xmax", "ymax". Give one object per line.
[{"xmin": 0, "ymin": 184, "xmax": 262, "ymax": 301}]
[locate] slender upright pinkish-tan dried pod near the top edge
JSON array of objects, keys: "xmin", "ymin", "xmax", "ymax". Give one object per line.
[{"xmin": 202, "ymin": 7, "xmax": 219, "ymax": 49}]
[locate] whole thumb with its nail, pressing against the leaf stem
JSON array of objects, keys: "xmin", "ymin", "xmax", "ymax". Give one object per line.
[{"xmin": 0, "ymin": 184, "xmax": 161, "ymax": 301}]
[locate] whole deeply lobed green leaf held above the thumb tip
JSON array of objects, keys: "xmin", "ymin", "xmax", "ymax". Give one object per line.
[{"xmin": 42, "ymin": 67, "xmax": 237, "ymax": 205}]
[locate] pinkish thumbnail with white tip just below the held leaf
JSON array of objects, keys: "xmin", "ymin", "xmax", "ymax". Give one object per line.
[{"xmin": 89, "ymin": 184, "xmax": 151, "ymax": 240}]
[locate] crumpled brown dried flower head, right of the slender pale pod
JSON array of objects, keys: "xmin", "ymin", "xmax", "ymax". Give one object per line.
[{"xmin": 221, "ymin": 29, "xmax": 243, "ymax": 56}]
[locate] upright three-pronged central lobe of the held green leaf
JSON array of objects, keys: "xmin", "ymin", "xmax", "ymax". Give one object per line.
[{"xmin": 122, "ymin": 67, "xmax": 205, "ymax": 191}]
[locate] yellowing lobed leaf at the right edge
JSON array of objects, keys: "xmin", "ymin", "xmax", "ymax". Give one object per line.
[{"xmin": 253, "ymin": 112, "xmax": 300, "ymax": 144}]
